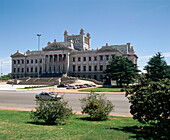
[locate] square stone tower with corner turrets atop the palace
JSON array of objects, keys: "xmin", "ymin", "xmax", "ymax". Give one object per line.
[{"xmin": 64, "ymin": 29, "xmax": 91, "ymax": 51}]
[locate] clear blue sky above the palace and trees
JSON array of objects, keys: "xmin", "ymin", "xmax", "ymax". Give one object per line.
[{"xmin": 0, "ymin": 0, "xmax": 170, "ymax": 75}]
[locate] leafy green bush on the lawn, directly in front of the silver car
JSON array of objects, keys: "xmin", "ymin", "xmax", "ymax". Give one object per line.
[{"xmin": 30, "ymin": 99, "xmax": 72, "ymax": 124}]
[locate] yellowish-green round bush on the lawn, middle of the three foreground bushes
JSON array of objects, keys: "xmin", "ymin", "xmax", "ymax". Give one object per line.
[{"xmin": 80, "ymin": 93, "xmax": 114, "ymax": 120}]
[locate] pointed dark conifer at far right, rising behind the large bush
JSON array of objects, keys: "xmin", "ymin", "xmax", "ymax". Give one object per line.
[{"xmin": 144, "ymin": 52, "xmax": 170, "ymax": 81}]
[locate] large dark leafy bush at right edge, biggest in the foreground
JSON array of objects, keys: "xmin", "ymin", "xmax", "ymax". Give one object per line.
[{"xmin": 126, "ymin": 76, "xmax": 170, "ymax": 129}]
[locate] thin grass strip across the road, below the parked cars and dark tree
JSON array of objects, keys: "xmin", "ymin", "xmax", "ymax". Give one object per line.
[{"xmin": 79, "ymin": 87, "xmax": 122, "ymax": 92}]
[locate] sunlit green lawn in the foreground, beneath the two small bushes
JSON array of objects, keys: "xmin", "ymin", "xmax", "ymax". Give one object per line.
[{"xmin": 0, "ymin": 110, "xmax": 166, "ymax": 140}]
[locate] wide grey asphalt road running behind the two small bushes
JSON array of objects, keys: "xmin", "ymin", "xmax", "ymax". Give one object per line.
[{"xmin": 0, "ymin": 90, "xmax": 130, "ymax": 114}]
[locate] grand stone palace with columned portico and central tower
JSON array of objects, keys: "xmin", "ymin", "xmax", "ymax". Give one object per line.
[{"xmin": 11, "ymin": 29, "xmax": 138, "ymax": 81}]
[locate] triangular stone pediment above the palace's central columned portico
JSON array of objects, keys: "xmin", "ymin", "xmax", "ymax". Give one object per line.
[{"xmin": 42, "ymin": 43, "xmax": 71, "ymax": 51}]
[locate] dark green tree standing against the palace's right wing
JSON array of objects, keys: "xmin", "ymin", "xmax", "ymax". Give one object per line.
[{"xmin": 104, "ymin": 56, "xmax": 139, "ymax": 86}]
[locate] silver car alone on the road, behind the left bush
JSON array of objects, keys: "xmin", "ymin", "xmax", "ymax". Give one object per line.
[{"xmin": 35, "ymin": 92, "xmax": 61, "ymax": 99}]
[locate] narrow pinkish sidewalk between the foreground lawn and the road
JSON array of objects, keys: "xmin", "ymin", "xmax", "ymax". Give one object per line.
[{"xmin": 0, "ymin": 106, "xmax": 132, "ymax": 117}]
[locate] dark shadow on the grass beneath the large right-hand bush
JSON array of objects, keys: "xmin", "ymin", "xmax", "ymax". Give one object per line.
[{"xmin": 108, "ymin": 126, "xmax": 170, "ymax": 140}]
